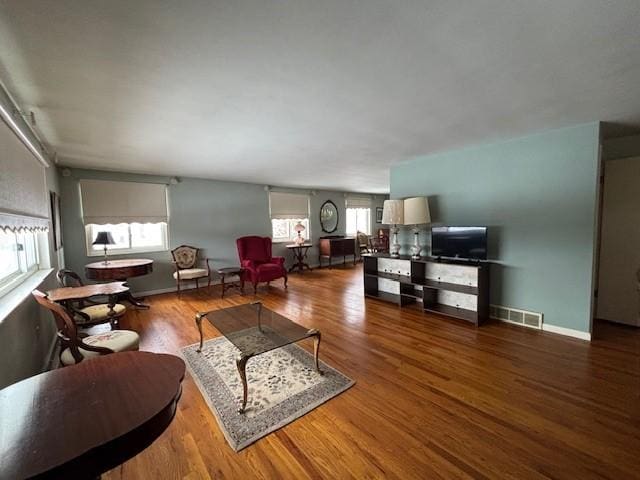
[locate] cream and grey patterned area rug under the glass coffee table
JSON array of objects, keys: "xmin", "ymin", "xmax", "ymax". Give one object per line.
[{"xmin": 182, "ymin": 329, "xmax": 355, "ymax": 452}]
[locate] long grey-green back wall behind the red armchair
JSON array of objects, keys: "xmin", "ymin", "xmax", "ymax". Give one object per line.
[{"xmin": 60, "ymin": 169, "xmax": 388, "ymax": 292}]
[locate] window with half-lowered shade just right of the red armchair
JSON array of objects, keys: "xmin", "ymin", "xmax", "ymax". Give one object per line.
[{"xmin": 269, "ymin": 192, "xmax": 311, "ymax": 242}]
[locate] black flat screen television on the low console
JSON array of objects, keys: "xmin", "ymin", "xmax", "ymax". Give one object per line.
[{"xmin": 431, "ymin": 227, "xmax": 487, "ymax": 260}]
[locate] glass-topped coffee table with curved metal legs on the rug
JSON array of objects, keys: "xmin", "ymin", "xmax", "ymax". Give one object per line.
[{"xmin": 196, "ymin": 302, "xmax": 323, "ymax": 413}]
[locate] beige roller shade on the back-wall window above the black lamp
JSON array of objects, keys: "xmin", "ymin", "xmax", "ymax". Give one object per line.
[{"xmin": 80, "ymin": 180, "xmax": 169, "ymax": 225}]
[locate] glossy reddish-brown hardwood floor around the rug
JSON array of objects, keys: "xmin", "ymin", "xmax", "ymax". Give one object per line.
[{"xmin": 104, "ymin": 266, "xmax": 640, "ymax": 480}]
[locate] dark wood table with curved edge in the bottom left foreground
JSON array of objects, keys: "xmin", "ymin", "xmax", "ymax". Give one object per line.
[{"xmin": 0, "ymin": 352, "xmax": 185, "ymax": 480}]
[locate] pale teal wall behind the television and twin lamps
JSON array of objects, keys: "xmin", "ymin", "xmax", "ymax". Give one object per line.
[{"xmin": 391, "ymin": 123, "xmax": 600, "ymax": 332}]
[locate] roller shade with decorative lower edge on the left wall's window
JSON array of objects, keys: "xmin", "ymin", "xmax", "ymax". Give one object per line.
[{"xmin": 0, "ymin": 121, "xmax": 49, "ymax": 232}]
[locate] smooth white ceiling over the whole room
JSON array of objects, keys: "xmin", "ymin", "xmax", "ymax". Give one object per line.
[{"xmin": 0, "ymin": 0, "xmax": 640, "ymax": 192}]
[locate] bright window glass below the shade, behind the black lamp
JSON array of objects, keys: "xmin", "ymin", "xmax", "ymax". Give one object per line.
[{"xmin": 85, "ymin": 222, "xmax": 168, "ymax": 256}]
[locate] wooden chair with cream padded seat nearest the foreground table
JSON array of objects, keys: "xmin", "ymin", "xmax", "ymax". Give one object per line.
[{"xmin": 31, "ymin": 287, "xmax": 140, "ymax": 365}]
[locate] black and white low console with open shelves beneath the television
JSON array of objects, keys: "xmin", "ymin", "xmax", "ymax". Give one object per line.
[{"xmin": 363, "ymin": 253, "xmax": 490, "ymax": 325}]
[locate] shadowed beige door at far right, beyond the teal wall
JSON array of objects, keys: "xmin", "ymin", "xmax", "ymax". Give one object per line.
[{"xmin": 596, "ymin": 156, "xmax": 640, "ymax": 326}]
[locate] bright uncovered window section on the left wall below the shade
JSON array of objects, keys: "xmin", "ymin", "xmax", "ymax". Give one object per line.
[{"xmin": 0, "ymin": 230, "xmax": 40, "ymax": 295}]
